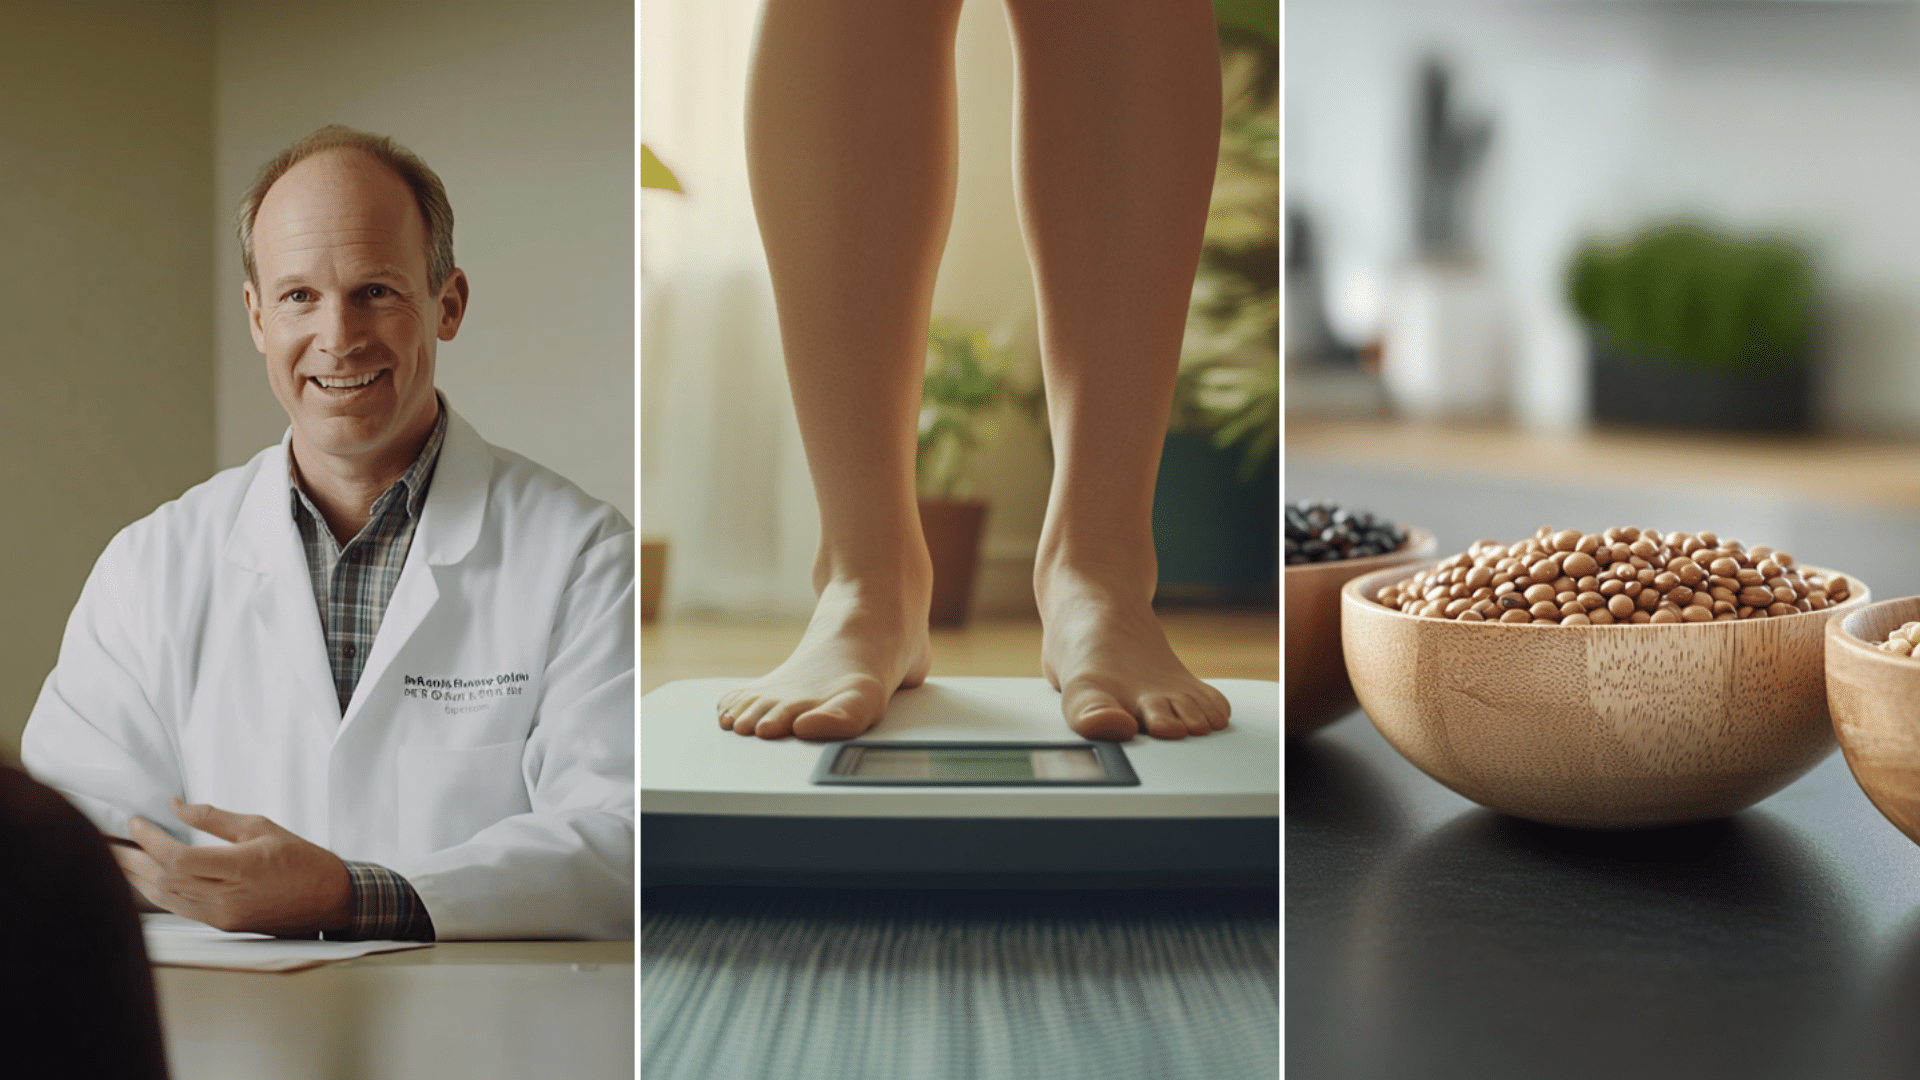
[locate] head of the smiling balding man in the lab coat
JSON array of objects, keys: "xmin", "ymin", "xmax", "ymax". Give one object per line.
[{"xmin": 246, "ymin": 150, "xmax": 467, "ymax": 475}]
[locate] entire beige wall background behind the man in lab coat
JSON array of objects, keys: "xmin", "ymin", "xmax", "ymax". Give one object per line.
[{"xmin": 0, "ymin": 0, "xmax": 634, "ymax": 761}]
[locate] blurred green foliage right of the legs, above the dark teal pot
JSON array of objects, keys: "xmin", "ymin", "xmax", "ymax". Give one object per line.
[{"xmin": 1169, "ymin": 2, "xmax": 1281, "ymax": 479}]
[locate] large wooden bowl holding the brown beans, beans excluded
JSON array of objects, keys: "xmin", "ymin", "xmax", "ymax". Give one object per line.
[{"xmin": 1340, "ymin": 565, "xmax": 1872, "ymax": 828}]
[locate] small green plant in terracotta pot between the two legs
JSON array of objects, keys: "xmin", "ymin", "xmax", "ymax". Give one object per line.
[{"xmin": 914, "ymin": 319, "xmax": 1043, "ymax": 626}]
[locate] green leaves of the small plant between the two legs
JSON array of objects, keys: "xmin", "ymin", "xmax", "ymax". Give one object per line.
[{"xmin": 914, "ymin": 317, "xmax": 1044, "ymax": 500}]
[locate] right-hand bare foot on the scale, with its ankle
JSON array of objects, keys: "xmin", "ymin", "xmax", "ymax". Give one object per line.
[{"xmin": 1035, "ymin": 571, "xmax": 1231, "ymax": 740}]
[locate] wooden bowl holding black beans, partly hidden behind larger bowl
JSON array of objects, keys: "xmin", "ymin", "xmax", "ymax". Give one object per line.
[{"xmin": 1284, "ymin": 528, "xmax": 1436, "ymax": 738}]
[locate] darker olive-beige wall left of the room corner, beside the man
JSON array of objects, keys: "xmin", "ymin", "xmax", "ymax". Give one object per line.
[{"xmin": 0, "ymin": 0, "xmax": 213, "ymax": 761}]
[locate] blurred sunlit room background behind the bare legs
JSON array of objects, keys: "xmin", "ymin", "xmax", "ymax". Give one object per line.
[{"xmin": 639, "ymin": 0, "xmax": 1281, "ymax": 690}]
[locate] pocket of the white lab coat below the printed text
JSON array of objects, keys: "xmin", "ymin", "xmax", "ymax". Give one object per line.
[{"xmin": 399, "ymin": 742, "xmax": 532, "ymax": 857}]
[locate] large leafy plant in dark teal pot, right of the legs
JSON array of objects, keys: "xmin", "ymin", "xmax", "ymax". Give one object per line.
[{"xmin": 1154, "ymin": 4, "xmax": 1281, "ymax": 601}]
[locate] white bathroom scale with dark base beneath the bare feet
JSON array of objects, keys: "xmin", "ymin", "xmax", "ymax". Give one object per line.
[{"xmin": 639, "ymin": 678, "xmax": 1283, "ymax": 888}]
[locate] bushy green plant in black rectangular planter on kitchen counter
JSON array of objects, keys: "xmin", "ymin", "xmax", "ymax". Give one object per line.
[{"xmin": 1567, "ymin": 225, "xmax": 1814, "ymax": 430}]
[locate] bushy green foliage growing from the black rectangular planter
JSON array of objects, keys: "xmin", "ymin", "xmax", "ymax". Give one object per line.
[{"xmin": 1567, "ymin": 225, "xmax": 1814, "ymax": 371}]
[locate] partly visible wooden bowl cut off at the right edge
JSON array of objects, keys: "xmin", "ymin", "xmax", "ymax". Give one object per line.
[{"xmin": 1826, "ymin": 596, "xmax": 1920, "ymax": 844}]
